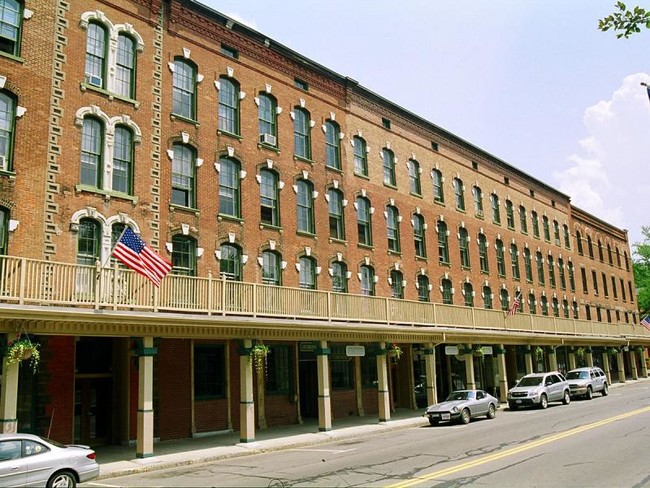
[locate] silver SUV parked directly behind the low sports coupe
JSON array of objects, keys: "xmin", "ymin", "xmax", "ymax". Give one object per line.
[{"xmin": 508, "ymin": 371, "xmax": 571, "ymax": 410}]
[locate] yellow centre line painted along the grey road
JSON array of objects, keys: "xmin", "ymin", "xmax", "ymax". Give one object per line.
[{"xmin": 388, "ymin": 407, "xmax": 650, "ymax": 488}]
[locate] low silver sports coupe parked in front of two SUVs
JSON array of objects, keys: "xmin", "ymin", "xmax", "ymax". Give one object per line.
[{"xmin": 424, "ymin": 390, "xmax": 499, "ymax": 425}]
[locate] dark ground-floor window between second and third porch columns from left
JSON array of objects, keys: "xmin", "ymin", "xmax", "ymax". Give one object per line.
[{"xmin": 194, "ymin": 344, "xmax": 226, "ymax": 400}]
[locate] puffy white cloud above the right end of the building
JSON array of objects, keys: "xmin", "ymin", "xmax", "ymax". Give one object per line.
[{"xmin": 553, "ymin": 73, "xmax": 650, "ymax": 248}]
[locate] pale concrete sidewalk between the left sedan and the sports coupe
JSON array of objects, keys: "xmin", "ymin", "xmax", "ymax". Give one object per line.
[{"xmin": 95, "ymin": 409, "xmax": 429, "ymax": 479}]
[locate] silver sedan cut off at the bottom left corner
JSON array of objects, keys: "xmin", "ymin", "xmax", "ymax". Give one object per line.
[{"xmin": 0, "ymin": 434, "xmax": 99, "ymax": 488}]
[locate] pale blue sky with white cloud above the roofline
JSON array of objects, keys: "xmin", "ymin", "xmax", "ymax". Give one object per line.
[{"xmin": 199, "ymin": 0, "xmax": 650, "ymax": 245}]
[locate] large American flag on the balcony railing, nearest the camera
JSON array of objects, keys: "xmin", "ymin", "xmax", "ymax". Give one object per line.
[{"xmin": 112, "ymin": 227, "xmax": 172, "ymax": 286}]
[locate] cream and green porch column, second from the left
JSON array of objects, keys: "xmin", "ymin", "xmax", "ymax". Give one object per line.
[{"xmin": 135, "ymin": 337, "xmax": 158, "ymax": 458}]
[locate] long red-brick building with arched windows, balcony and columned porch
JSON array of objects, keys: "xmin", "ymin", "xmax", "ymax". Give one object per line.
[{"xmin": 0, "ymin": 0, "xmax": 650, "ymax": 457}]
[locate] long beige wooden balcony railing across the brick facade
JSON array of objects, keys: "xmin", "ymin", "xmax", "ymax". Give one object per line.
[{"xmin": 0, "ymin": 256, "xmax": 650, "ymax": 340}]
